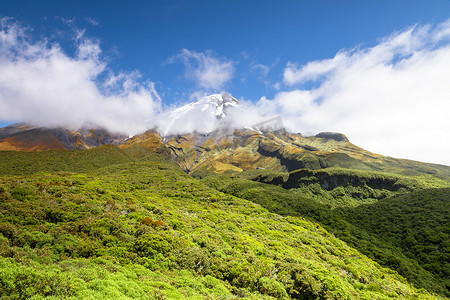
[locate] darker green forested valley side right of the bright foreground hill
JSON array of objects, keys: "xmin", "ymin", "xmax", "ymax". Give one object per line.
[{"xmin": 202, "ymin": 170, "xmax": 450, "ymax": 296}]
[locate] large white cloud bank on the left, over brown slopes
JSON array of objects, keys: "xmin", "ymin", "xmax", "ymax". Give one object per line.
[{"xmin": 0, "ymin": 19, "xmax": 161, "ymax": 134}]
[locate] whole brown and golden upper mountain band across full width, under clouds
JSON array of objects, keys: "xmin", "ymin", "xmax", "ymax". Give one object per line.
[{"xmin": 0, "ymin": 122, "xmax": 450, "ymax": 181}]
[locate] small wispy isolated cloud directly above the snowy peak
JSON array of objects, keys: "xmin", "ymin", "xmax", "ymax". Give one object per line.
[{"xmin": 171, "ymin": 49, "xmax": 234, "ymax": 91}]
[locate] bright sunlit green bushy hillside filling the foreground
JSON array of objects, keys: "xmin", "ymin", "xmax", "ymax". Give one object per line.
[{"xmin": 0, "ymin": 152, "xmax": 439, "ymax": 299}]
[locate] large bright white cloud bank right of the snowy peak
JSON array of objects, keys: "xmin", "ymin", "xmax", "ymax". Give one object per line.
[{"xmin": 258, "ymin": 21, "xmax": 450, "ymax": 165}]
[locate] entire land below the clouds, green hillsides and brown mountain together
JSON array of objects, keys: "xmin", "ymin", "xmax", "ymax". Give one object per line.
[{"xmin": 0, "ymin": 116, "xmax": 450, "ymax": 299}]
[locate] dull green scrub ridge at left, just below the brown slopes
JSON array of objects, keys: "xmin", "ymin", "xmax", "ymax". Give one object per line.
[{"xmin": 0, "ymin": 145, "xmax": 131, "ymax": 176}]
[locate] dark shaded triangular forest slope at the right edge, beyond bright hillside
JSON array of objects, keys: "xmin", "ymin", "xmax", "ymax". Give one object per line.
[{"xmin": 343, "ymin": 188, "xmax": 450, "ymax": 296}]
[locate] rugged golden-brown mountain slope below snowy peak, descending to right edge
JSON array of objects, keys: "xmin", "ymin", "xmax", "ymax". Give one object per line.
[{"xmin": 164, "ymin": 129, "xmax": 450, "ymax": 178}]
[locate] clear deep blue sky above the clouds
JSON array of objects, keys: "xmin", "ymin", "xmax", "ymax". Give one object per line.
[{"xmin": 0, "ymin": 0, "xmax": 450, "ymax": 103}]
